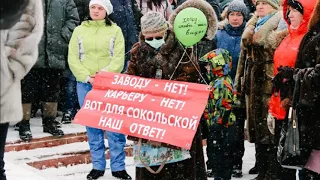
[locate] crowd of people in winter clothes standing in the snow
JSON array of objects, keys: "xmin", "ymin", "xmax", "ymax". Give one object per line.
[{"xmin": 0, "ymin": 0, "xmax": 320, "ymax": 180}]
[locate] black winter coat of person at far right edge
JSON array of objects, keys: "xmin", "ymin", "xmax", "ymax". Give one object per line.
[{"xmin": 295, "ymin": 0, "xmax": 320, "ymax": 152}]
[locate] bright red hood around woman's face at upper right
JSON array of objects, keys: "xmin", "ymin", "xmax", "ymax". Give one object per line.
[{"xmin": 283, "ymin": 0, "xmax": 317, "ymax": 37}]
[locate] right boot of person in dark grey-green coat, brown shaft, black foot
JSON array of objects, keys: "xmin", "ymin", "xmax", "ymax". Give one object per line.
[{"xmin": 42, "ymin": 102, "xmax": 64, "ymax": 137}]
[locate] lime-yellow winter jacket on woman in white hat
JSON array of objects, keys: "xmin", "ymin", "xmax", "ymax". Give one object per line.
[{"xmin": 68, "ymin": 20, "xmax": 125, "ymax": 82}]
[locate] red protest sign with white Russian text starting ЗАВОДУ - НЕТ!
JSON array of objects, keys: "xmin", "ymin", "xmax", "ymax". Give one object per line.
[{"xmin": 74, "ymin": 72, "xmax": 209, "ymax": 149}]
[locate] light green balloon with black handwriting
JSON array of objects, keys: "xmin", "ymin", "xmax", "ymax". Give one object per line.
[{"xmin": 173, "ymin": 7, "xmax": 208, "ymax": 47}]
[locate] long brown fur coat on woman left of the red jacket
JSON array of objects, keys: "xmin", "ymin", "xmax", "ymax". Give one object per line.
[{"xmin": 235, "ymin": 12, "xmax": 282, "ymax": 144}]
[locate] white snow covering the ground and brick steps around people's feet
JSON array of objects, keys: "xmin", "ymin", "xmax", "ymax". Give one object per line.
[{"xmin": 5, "ymin": 118, "xmax": 255, "ymax": 180}]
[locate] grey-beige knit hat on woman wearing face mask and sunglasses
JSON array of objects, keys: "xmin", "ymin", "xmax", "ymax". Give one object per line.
[{"xmin": 141, "ymin": 11, "xmax": 168, "ymax": 35}]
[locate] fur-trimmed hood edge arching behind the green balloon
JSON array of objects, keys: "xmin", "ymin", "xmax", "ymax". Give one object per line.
[{"xmin": 169, "ymin": 0, "xmax": 218, "ymax": 40}]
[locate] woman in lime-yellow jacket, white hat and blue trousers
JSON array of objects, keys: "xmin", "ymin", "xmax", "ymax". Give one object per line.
[{"xmin": 68, "ymin": 0, "xmax": 131, "ymax": 179}]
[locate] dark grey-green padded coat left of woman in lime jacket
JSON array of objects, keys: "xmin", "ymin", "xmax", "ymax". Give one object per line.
[{"xmin": 34, "ymin": 0, "xmax": 80, "ymax": 69}]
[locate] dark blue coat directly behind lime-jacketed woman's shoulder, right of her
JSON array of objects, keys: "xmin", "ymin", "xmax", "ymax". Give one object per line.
[{"xmin": 109, "ymin": 0, "xmax": 139, "ymax": 70}]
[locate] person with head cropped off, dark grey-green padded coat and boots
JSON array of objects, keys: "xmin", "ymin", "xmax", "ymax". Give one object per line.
[{"xmin": 19, "ymin": 0, "xmax": 79, "ymax": 141}]
